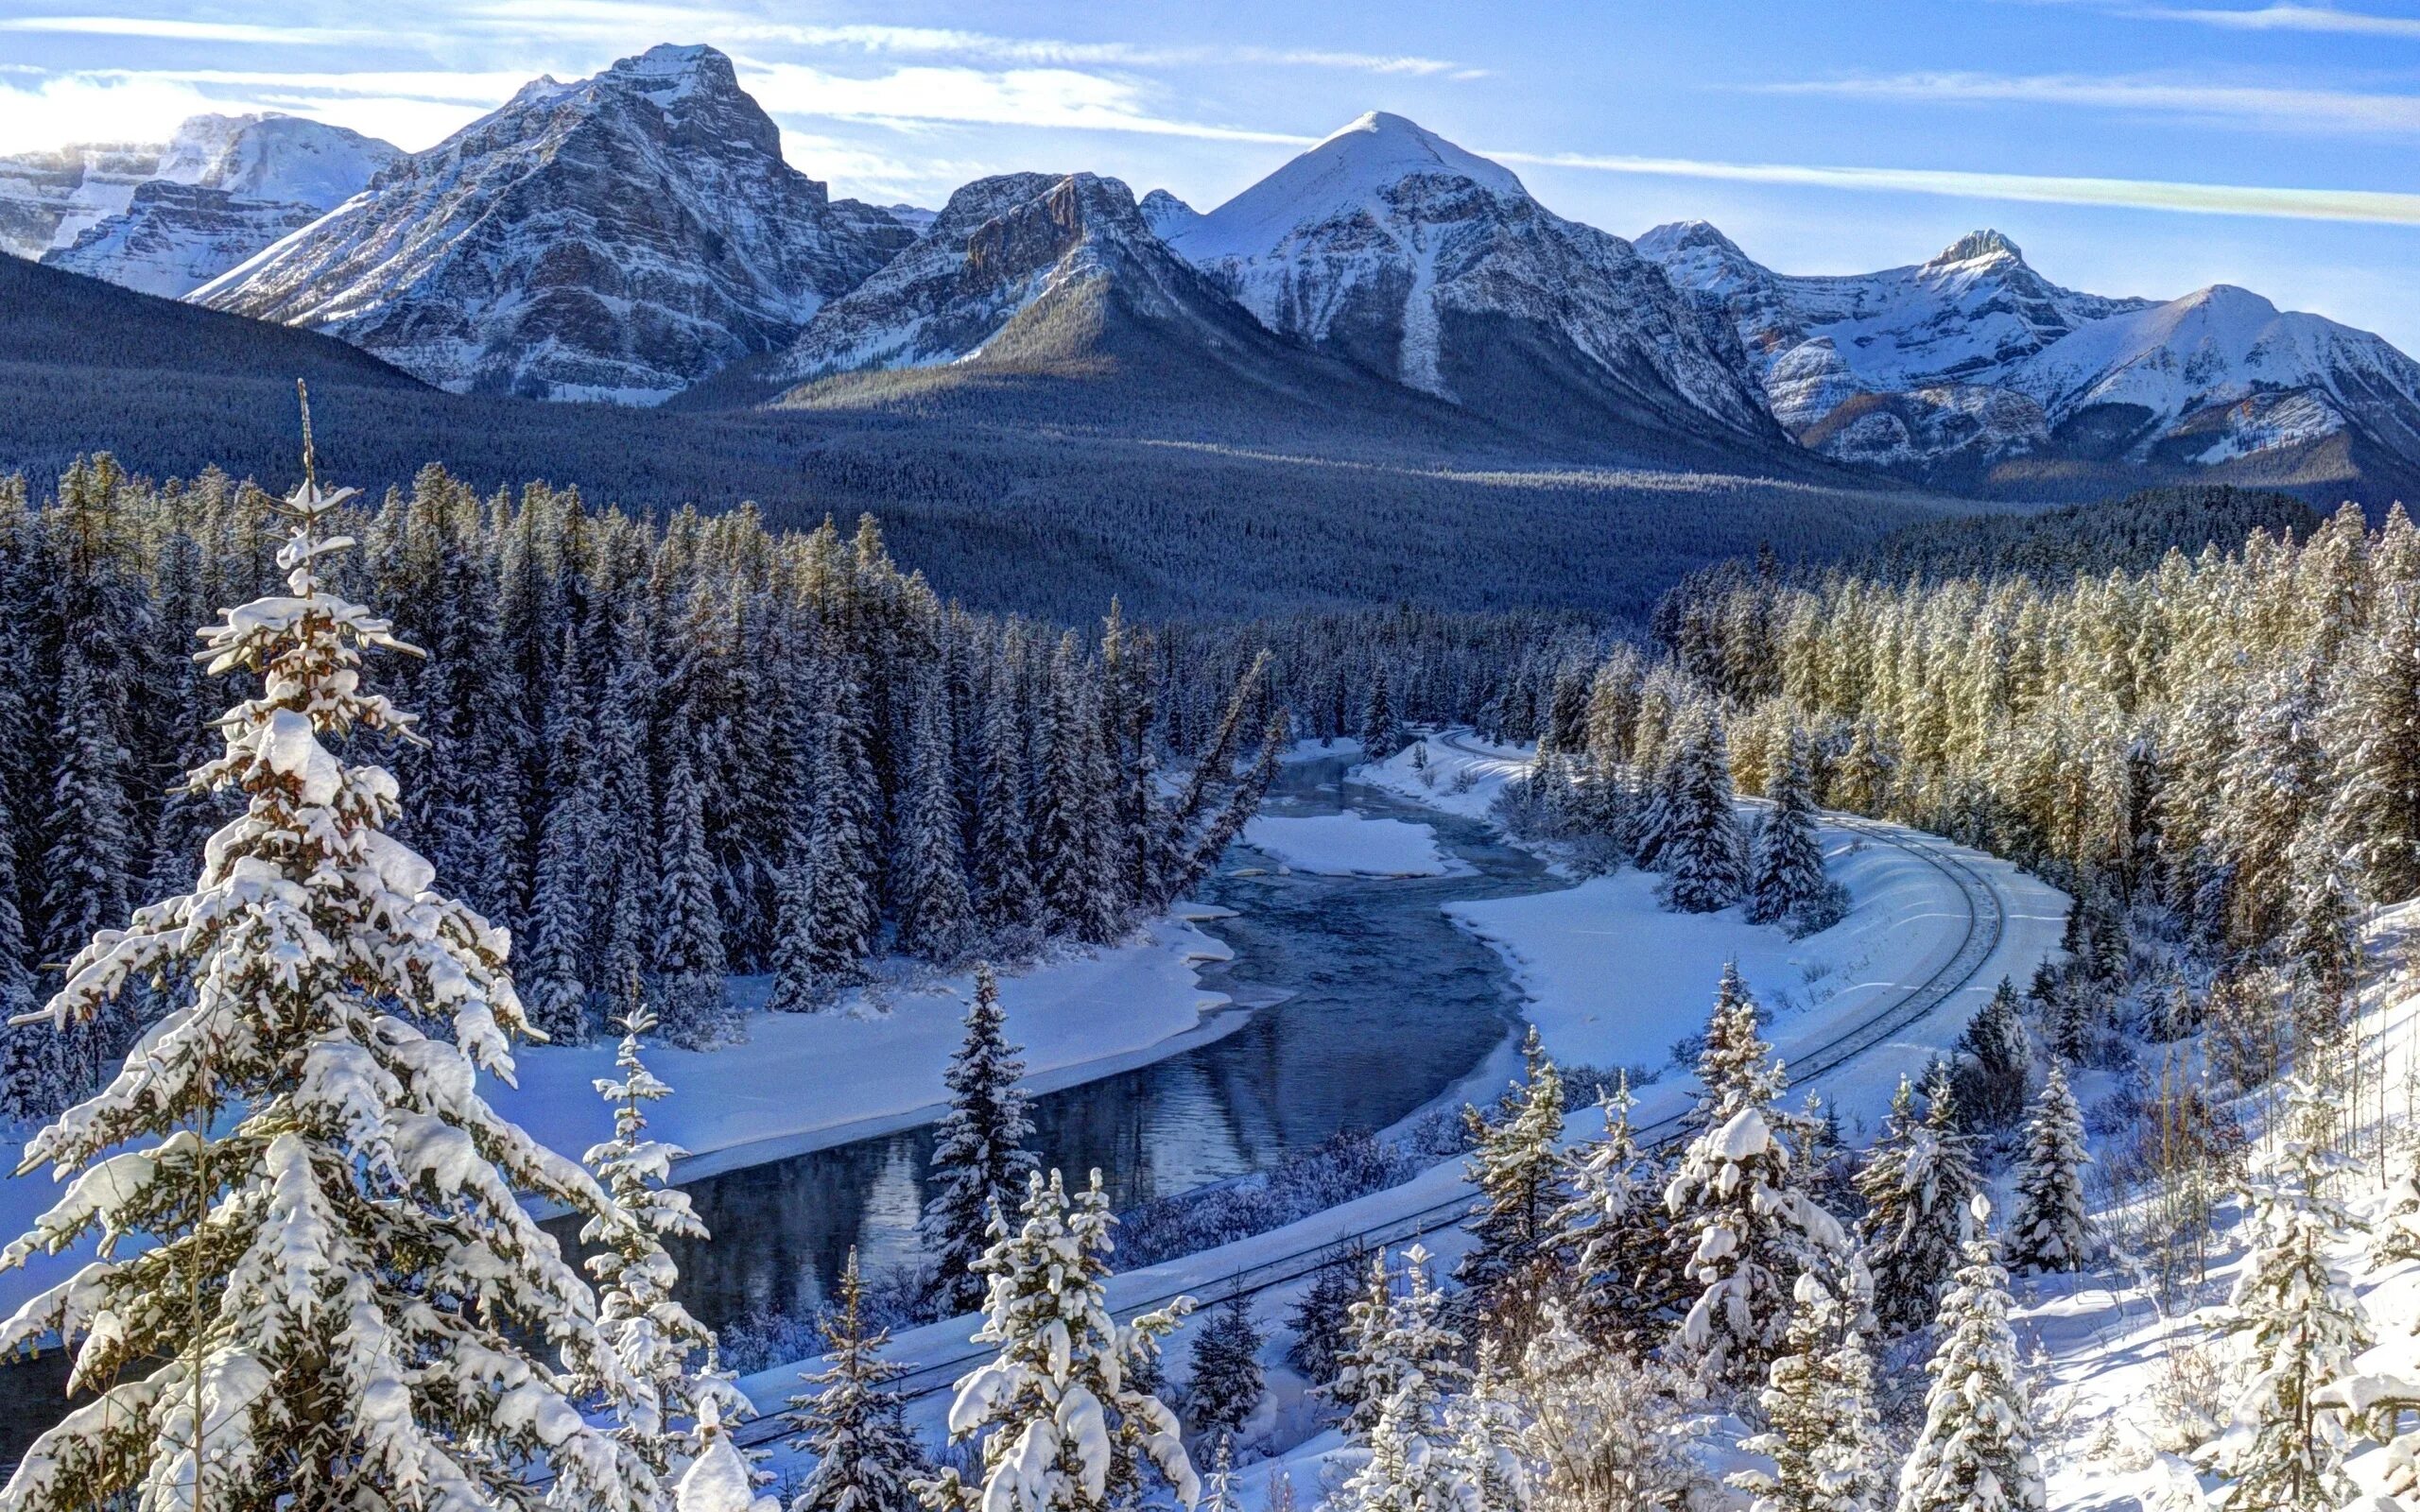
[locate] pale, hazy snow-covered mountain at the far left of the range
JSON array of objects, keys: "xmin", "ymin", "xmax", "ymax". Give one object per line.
[{"xmin": 12, "ymin": 116, "xmax": 405, "ymax": 298}]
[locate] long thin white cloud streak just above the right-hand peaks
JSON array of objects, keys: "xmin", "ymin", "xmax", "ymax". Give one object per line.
[{"xmin": 1488, "ymin": 152, "xmax": 2420, "ymax": 225}]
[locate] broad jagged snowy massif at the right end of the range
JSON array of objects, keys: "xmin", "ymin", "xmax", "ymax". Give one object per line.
[{"xmin": 1638, "ymin": 220, "xmax": 2420, "ymax": 472}]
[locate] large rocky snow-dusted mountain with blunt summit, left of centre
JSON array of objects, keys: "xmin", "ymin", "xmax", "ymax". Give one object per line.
[{"xmin": 191, "ymin": 46, "xmax": 915, "ymax": 404}]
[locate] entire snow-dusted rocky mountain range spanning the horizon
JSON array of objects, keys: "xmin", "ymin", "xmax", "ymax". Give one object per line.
[{"xmin": 0, "ymin": 35, "xmax": 2420, "ymax": 498}]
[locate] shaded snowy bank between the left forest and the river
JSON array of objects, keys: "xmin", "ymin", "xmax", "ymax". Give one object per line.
[{"xmin": 0, "ymin": 904, "xmax": 1246, "ymax": 1316}]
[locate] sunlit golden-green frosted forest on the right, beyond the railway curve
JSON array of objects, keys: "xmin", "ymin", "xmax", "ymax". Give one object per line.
[{"xmin": 1658, "ymin": 506, "xmax": 2420, "ymax": 960}]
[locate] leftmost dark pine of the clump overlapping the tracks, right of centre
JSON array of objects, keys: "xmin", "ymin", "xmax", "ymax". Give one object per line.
[{"xmin": 1455, "ymin": 1023, "xmax": 1564, "ymax": 1333}]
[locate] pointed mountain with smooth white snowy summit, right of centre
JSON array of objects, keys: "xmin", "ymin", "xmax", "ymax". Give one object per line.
[{"xmin": 1145, "ymin": 113, "xmax": 1781, "ymax": 445}]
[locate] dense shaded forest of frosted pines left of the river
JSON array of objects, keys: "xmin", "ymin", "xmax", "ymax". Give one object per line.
[{"xmin": 0, "ymin": 457, "xmax": 1280, "ymax": 1118}]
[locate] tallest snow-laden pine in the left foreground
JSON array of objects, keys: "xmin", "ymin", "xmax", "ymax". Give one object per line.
[{"xmin": 0, "ymin": 450, "xmax": 658, "ymax": 1512}]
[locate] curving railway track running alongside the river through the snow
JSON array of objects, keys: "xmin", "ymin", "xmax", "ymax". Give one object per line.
[{"xmin": 711, "ymin": 759, "xmax": 2009, "ymax": 1447}]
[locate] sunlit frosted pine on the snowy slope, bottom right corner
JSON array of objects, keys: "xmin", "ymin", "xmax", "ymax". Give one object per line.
[{"xmin": 2204, "ymin": 1076, "xmax": 2369, "ymax": 1512}]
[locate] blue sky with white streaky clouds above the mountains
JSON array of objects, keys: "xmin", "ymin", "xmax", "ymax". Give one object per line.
[{"xmin": 0, "ymin": 0, "xmax": 2420, "ymax": 351}]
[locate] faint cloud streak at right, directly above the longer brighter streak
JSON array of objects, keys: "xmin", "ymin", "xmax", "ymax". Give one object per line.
[{"xmin": 1754, "ymin": 73, "xmax": 2420, "ymax": 135}]
